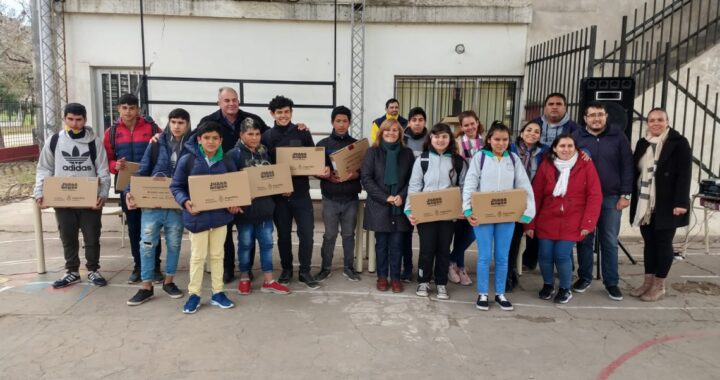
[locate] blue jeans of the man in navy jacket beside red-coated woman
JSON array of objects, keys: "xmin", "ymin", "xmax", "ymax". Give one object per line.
[{"xmin": 577, "ymin": 195, "xmax": 622, "ymax": 287}]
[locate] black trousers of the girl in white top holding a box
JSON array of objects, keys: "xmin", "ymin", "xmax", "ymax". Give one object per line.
[{"xmin": 417, "ymin": 221, "xmax": 455, "ymax": 285}]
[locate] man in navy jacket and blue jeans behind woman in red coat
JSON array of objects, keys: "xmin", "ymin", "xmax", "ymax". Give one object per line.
[{"xmin": 573, "ymin": 102, "xmax": 633, "ymax": 301}]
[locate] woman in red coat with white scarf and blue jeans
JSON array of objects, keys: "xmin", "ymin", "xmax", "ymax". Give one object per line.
[{"xmin": 525, "ymin": 134, "xmax": 602, "ymax": 303}]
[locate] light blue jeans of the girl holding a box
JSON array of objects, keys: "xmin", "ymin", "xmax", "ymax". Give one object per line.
[{"xmin": 475, "ymin": 222, "xmax": 515, "ymax": 294}]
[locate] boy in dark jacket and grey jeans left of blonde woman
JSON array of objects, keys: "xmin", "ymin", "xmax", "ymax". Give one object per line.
[{"xmin": 315, "ymin": 106, "xmax": 362, "ymax": 281}]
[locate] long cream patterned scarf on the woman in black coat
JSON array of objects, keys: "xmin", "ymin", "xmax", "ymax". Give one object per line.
[{"xmin": 632, "ymin": 127, "xmax": 670, "ymax": 227}]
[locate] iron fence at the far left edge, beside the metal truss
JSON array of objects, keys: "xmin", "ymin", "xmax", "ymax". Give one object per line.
[{"xmin": 0, "ymin": 101, "xmax": 37, "ymax": 149}]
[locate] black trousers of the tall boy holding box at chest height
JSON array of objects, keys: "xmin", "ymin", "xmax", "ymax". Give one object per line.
[{"xmin": 273, "ymin": 193, "xmax": 315, "ymax": 273}]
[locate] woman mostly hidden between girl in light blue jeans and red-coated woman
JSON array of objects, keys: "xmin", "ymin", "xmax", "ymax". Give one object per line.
[{"xmin": 505, "ymin": 121, "xmax": 548, "ymax": 292}]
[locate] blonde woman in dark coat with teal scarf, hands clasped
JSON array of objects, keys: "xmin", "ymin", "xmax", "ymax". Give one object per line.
[{"xmin": 360, "ymin": 119, "xmax": 415, "ymax": 293}]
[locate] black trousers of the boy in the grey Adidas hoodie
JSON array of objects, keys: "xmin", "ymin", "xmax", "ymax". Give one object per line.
[{"xmin": 55, "ymin": 208, "xmax": 102, "ymax": 272}]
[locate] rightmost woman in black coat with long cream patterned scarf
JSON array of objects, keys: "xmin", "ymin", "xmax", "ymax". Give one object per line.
[{"xmin": 630, "ymin": 108, "xmax": 692, "ymax": 302}]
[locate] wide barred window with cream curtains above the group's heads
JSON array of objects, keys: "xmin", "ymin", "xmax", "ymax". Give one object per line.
[{"xmin": 395, "ymin": 76, "xmax": 522, "ymax": 130}]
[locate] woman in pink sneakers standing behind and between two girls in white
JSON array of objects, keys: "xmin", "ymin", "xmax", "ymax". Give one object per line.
[{"xmin": 448, "ymin": 111, "xmax": 485, "ymax": 286}]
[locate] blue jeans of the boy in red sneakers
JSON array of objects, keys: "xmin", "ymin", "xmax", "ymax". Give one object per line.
[{"xmin": 237, "ymin": 219, "xmax": 273, "ymax": 273}]
